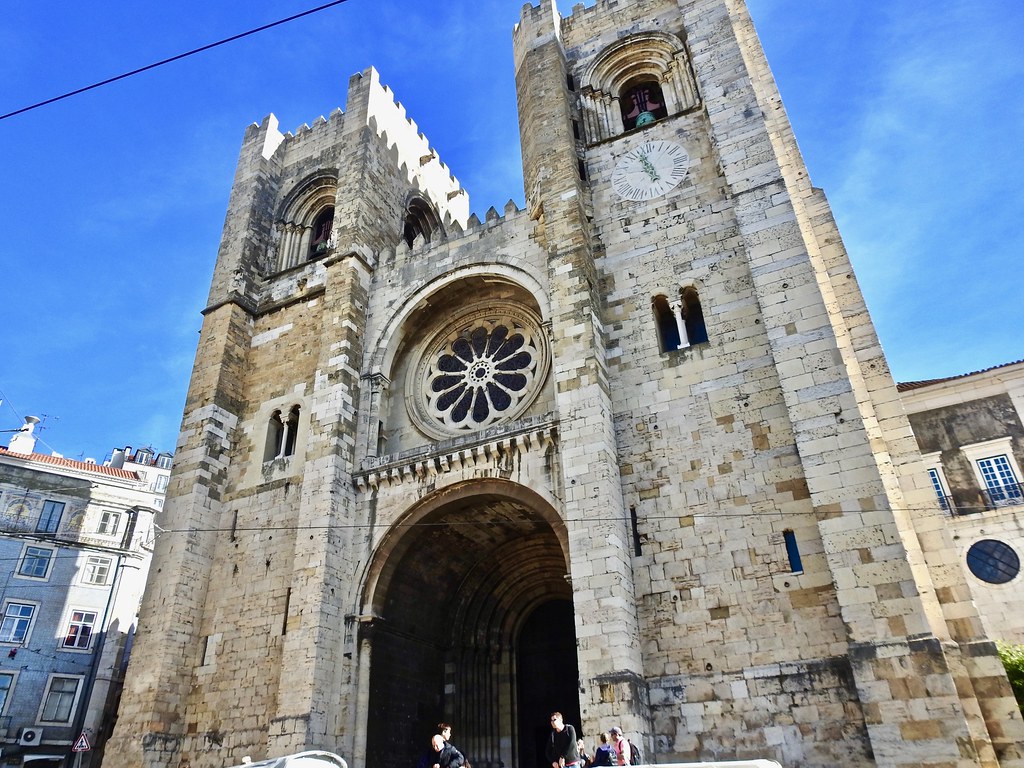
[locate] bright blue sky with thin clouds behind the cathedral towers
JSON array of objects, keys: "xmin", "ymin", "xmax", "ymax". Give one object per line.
[{"xmin": 0, "ymin": 0, "xmax": 1024, "ymax": 460}]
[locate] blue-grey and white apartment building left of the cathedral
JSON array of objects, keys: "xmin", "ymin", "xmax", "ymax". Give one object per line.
[{"xmin": 0, "ymin": 417, "xmax": 171, "ymax": 768}]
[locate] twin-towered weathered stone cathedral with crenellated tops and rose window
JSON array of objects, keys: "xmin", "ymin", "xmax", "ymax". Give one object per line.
[{"xmin": 104, "ymin": 0, "xmax": 1024, "ymax": 768}]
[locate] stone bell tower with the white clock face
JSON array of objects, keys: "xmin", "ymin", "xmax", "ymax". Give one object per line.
[{"xmin": 515, "ymin": 0, "xmax": 1021, "ymax": 765}]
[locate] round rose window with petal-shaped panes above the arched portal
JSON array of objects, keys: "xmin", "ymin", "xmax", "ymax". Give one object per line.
[{"xmin": 408, "ymin": 304, "xmax": 548, "ymax": 438}]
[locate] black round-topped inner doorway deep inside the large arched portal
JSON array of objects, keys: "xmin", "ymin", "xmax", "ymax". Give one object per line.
[{"xmin": 517, "ymin": 600, "xmax": 583, "ymax": 768}]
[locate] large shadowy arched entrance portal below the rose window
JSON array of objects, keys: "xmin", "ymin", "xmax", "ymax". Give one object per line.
[{"xmin": 358, "ymin": 481, "xmax": 580, "ymax": 768}]
